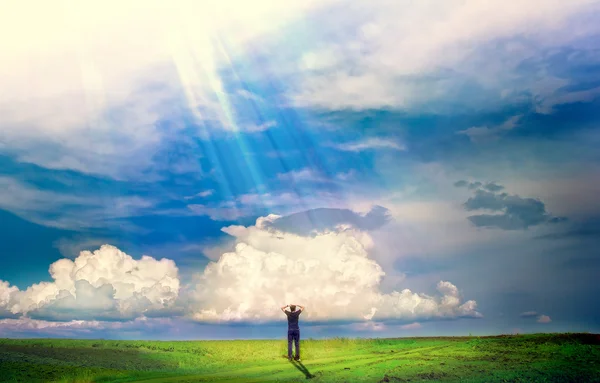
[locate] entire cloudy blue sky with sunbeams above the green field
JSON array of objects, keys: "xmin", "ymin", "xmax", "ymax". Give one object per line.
[{"xmin": 0, "ymin": 0, "xmax": 600, "ymax": 339}]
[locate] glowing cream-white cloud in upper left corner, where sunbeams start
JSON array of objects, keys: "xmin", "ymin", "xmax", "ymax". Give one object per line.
[{"xmin": 0, "ymin": 0, "xmax": 338, "ymax": 178}]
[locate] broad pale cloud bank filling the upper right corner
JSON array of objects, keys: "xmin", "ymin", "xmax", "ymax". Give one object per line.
[{"xmin": 293, "ymin": 0, "xmax": 599, "ymax": 110}]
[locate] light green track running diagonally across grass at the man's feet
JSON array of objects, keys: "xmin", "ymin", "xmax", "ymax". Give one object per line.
[{"xmin": 130, "ymin": 345, "xmax": 450, "ymax": 383}]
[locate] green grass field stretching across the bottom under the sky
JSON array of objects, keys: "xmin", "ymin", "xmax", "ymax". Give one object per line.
[{"xmin": 0, "ymin": 334, "xmax": 600, "ymax": 383}]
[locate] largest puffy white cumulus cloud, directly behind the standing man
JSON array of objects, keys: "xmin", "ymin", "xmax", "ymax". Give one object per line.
[{"xmin": 190, "ymin": 215, "xmax": 481, "ymax": 322}]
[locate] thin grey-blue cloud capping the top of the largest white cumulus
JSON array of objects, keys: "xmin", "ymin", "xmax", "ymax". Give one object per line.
[{"xmin": 269, "ymin": 206, "xmax": 391, "ymax": 235}]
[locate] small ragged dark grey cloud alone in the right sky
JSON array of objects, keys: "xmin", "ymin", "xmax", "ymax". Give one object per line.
[{"xmin": 455, "ymin": 181, "xmax": 566, "ymax": 230}]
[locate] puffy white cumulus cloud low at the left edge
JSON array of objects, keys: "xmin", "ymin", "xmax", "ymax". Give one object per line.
[{"xmin": 0, "ymin": 245, "xmax": 179, "ymax": 321}]
